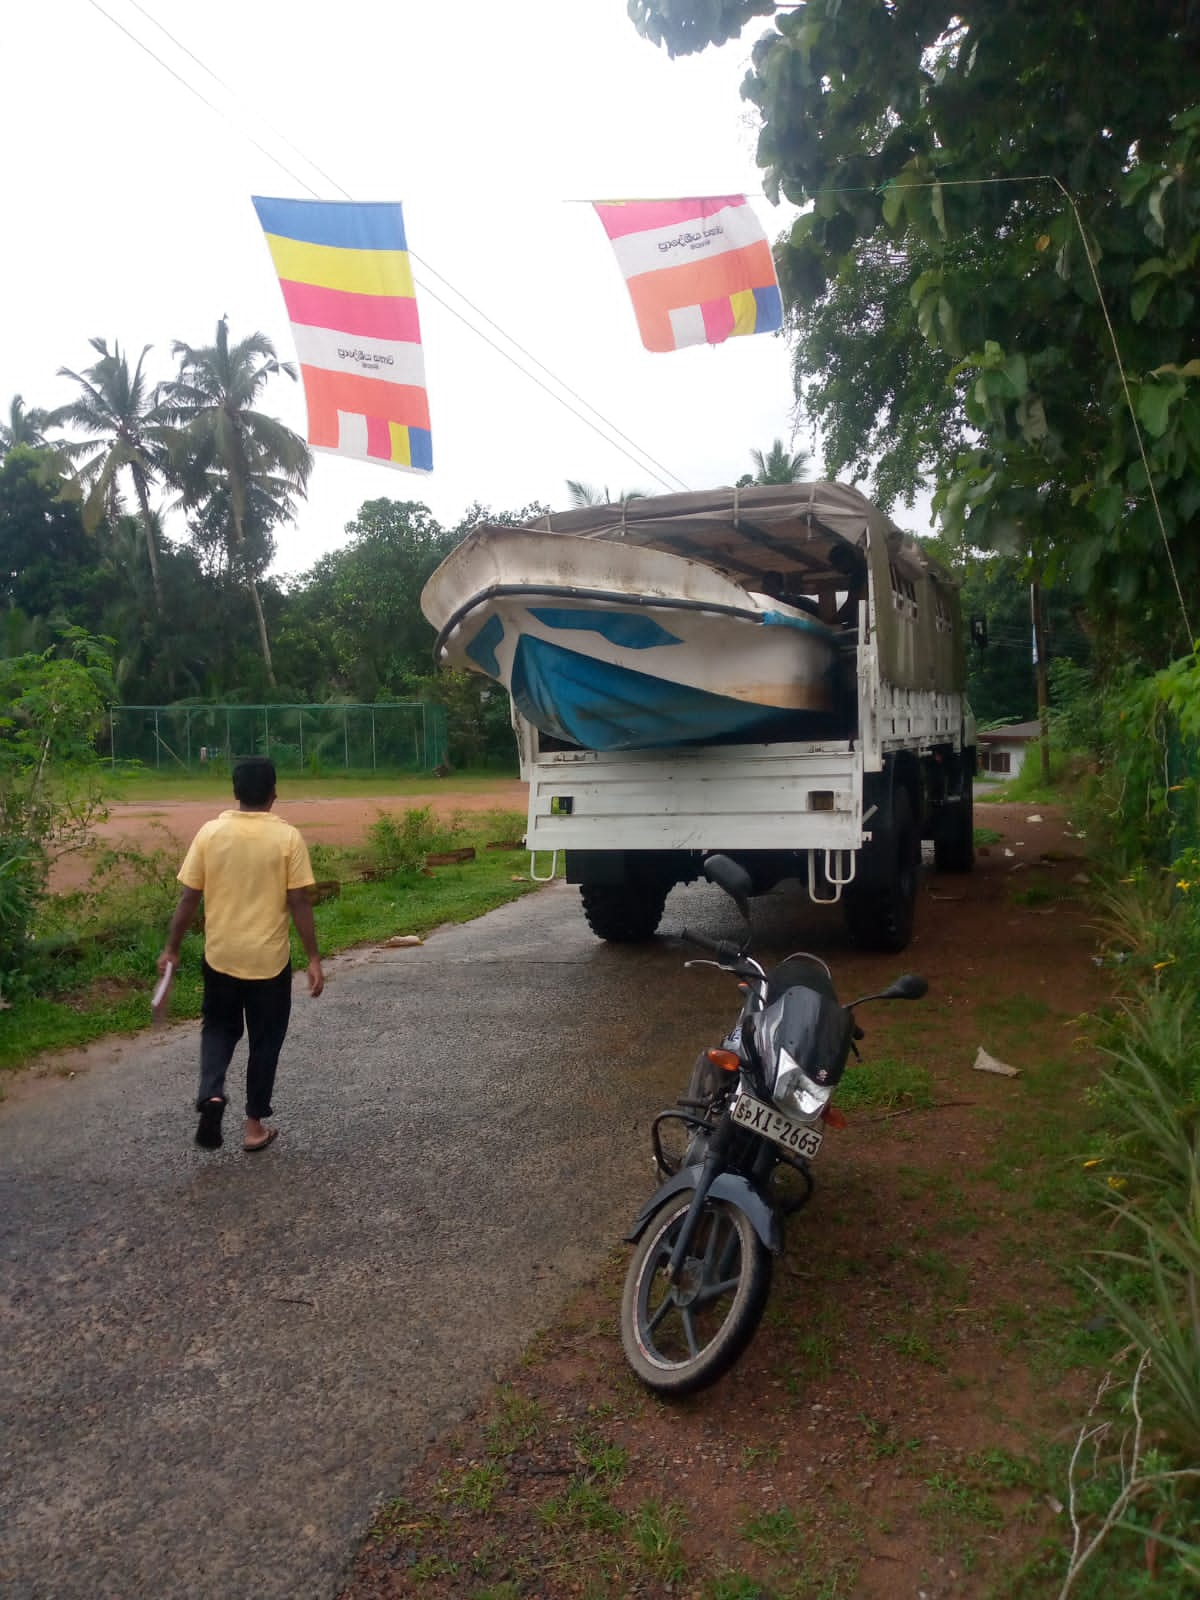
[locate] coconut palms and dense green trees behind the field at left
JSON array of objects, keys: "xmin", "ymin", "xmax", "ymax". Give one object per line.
[{"xmin": 9, "ymin": 318, "xmax": 546, "ymax": 761}]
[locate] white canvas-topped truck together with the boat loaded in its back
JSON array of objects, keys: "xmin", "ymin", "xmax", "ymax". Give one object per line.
[{"xmin": 421, "ymin": 483, "xmax": 974, "ymax": 950}]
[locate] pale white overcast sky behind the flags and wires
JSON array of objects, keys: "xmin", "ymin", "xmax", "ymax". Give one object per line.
[{"xmin": 0, "ymin": 0, "xmax": 844, "ymax": 571}]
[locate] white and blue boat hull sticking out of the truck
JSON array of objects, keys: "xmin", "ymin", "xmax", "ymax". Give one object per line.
[{"xmin": 422, "ymin": 528, "xmax": 835, "ymax": 750}]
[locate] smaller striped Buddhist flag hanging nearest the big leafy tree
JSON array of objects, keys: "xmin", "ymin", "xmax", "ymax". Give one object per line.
[{"xmin": 594, "ymin": 195, "xmax": 784, "ymax": 350}]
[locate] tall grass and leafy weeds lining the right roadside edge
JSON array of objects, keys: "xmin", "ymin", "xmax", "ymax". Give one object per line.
[{"xmin": 1061, "ymin": 654, "xmax": 1200, "ymax": 1594}]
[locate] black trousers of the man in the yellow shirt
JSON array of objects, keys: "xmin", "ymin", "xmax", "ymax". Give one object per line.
[{"xmin": 195, "ymin": 962, "xmax": 291, "ymax": 1117}]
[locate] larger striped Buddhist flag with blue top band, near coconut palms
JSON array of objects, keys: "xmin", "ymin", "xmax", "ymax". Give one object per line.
[{"xmin": 254, "ymin": 195, "xmax": 434, "ymax": 472}]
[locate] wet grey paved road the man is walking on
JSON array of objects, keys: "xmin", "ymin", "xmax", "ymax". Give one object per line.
[{"xmin": 0, "ymin": 886, "xmax": 748, "ymax": 1600}]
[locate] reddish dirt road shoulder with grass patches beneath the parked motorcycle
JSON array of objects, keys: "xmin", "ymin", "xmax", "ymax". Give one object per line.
[{"xmin": 342, "ymin": 805, "xmax": 1107, "ymax": 1600}]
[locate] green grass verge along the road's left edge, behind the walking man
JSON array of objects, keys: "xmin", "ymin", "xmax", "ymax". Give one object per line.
[{"xmin": 0, "ymin": 813, "xmax": 538, "ymax": 1069}]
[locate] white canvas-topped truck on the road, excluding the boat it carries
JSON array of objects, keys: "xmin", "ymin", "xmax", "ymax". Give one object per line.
[{"xmin": 427, "ymin": 483, "xmax": 976, "ymax": 950}]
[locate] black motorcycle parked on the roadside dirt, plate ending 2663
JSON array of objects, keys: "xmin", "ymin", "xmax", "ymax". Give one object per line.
[{"xmin": 621, "ymin": 854, "xmax": 928, "ymax": 1395}]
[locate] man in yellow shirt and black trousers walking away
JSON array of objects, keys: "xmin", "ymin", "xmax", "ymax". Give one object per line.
[{"xmin": 158, "ymin": 757, "xmax": 325, "ymax": 1152}]
